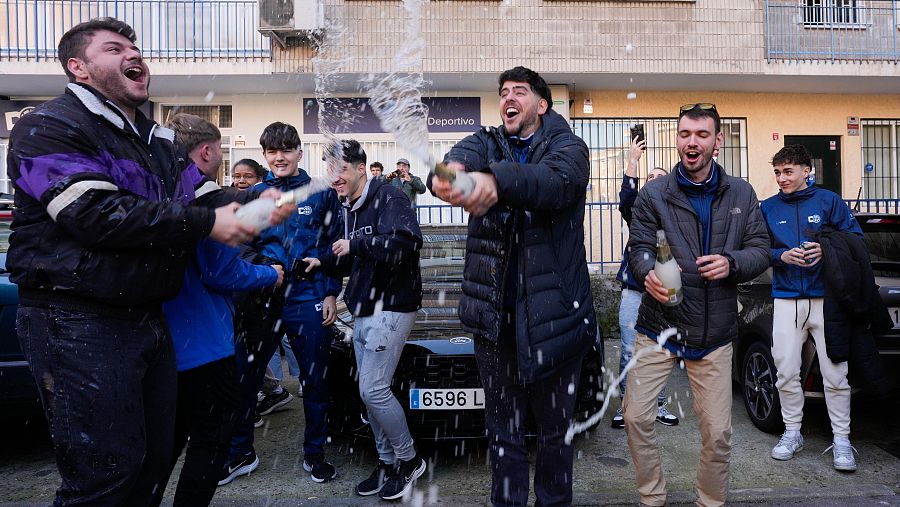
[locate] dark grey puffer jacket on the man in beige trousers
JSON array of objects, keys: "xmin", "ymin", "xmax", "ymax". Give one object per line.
[{"xmin": 628, "ymin": 165, "xmax": 769, "ymax": 348}]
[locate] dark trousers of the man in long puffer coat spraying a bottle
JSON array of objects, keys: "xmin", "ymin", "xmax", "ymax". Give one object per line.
[{"xmin": 475, "ymin": 326, "xmax": 581, "ymax": 506}]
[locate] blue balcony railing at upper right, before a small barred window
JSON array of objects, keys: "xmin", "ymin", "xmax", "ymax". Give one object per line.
[{"xmin": 765, "ymin": 0, "xmax": 900, "ymax": 63}]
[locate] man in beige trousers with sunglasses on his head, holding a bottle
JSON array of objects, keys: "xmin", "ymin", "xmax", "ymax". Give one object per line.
[{"xmin": 624, "ymin": 103, "xmax": 769, "ymax": 506}]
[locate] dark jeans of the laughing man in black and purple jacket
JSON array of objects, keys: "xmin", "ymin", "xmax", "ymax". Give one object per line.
[{"xmin": 16, "ymin": 306, "xmax": 176, "ymax": 505}]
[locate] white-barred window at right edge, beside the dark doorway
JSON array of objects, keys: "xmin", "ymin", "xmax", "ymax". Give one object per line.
[{"xmin": 860, "ymin": 119, "xmax": 900, "ymax": 199}]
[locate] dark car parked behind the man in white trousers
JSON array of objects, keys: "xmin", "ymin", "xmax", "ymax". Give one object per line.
[{"xmin": 733, "ymin": 213, "xmax": 900, "ymax": 433}]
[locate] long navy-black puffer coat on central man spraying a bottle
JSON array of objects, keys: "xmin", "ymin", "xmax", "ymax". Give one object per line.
[{"xmin": 438, "ymin": 110, "xmax": 597, "ymax": 380}]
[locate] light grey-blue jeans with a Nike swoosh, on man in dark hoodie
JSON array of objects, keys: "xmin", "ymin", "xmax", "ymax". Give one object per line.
[{"xmin": 356, "ymin": 312, "xmax": 416, "ymax": 464}]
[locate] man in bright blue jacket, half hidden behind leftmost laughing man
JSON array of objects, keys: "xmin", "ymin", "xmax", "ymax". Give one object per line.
[{"xmin": 154, "ymin": 114, "xmax": 284, "ymax": 505}]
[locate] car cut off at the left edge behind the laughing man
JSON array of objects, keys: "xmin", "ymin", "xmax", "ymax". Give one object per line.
[{"xmin": 0, "ymin": 194, "xmax": 40, "ymax": 408}]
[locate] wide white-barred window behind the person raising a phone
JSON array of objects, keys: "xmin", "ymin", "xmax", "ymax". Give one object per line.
[{"xmin": 572, "ymin": 118, "xmax": 749, "ymax": 203}]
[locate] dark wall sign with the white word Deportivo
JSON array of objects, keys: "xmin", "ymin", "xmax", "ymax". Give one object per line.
[{"xmin": 303, "ymin": 97, "xmax": 481, "ymax": 134}]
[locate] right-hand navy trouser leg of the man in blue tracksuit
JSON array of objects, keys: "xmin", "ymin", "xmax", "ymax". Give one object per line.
[{"xmin": 281, "ymin": 301, "xmax": 331, "ymax": 455}]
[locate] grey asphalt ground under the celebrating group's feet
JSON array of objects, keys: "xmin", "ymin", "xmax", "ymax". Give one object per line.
[{"xmin": 0, "ymin": 342, "xmax": 900, "ymax": 507}]
